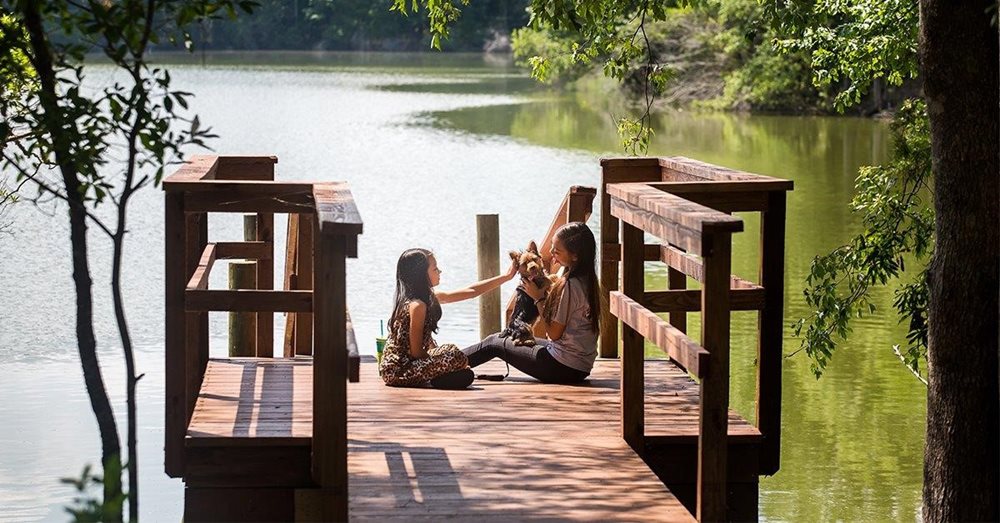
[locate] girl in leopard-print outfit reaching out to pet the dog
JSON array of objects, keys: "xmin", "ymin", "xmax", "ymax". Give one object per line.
[{"xmin": 379, "ymin": 249, "xmax": 517, "ymax": 389}]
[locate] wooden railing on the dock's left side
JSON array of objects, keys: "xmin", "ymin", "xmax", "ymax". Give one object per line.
[{"xmin": 163, "ymin": 156, "xmax": 362, "ymax": 520}]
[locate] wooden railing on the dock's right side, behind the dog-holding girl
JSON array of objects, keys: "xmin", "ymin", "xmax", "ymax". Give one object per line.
[{"xmin": 600, "ymin": 157, "xmax": 792, "ymax": 520}]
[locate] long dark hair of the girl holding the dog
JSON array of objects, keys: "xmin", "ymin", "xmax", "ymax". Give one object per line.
[{"xmin": 542, "ymin": 222, "xmax": 603, "ymax": 332}]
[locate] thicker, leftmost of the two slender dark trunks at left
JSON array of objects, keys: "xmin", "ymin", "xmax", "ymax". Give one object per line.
[{"xmin": 19, "ymin": 2, "xmax": 122, "ymax": 521}]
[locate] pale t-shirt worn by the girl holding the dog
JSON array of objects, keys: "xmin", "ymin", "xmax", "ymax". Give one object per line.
[{"xmin": 548, "ymin": 278, "xmax": 597, "ymax": 373}]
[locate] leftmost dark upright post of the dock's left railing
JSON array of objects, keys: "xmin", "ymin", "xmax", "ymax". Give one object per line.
[{"xmin": 163, "ymin": 192, "xmax": 188, "ymax": 478}]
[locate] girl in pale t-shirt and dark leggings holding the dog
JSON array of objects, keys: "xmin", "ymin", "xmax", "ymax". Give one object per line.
[{"xmin": 462, "ymin": 222, "xmax": 601, "ymax": 383}]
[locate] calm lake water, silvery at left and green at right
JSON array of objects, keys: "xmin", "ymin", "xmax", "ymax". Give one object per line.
[{"xmin": 0, "ymin": 53, "xmax": 926, "ymax": 521}]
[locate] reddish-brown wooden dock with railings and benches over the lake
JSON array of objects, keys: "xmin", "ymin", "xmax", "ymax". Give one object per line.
[{"xmin": 163, "ymin": 156, "xmax": 792, "ymax": 522}]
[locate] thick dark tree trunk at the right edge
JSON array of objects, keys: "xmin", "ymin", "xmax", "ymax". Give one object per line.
[{"xmin": 920, "ymin": 0, "xmax": 1000, "ymax": 522}]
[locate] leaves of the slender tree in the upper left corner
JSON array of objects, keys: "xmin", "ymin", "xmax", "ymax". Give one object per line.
[{"xmin": 0, "ymin": 0, "xmax": 251, "ymax": 201}]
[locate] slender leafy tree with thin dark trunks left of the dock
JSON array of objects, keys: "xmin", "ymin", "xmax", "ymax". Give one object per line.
[{"xmin": 0, "ymin": 0, "xmax": 254, "ymax": 521}]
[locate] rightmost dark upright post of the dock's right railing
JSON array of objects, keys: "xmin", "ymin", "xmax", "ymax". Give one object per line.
[{"xmin": 756, "ymin": 191, "xmax": 785, "ymax": 475}]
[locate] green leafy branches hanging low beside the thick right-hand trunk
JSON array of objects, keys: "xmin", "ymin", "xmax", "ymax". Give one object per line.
[{"xmin": 793, "ymin": 100, "xmax": 934, "ymax": 377}]
